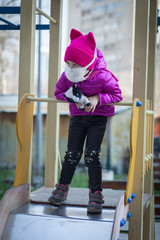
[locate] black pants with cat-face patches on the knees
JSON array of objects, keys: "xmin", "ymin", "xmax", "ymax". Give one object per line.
[{"xmin": 59, "ymin": 115, "xmax": 107, "ymax": 191}]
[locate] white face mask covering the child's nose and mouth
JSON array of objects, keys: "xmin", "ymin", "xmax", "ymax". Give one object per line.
[{"xmin": 65, "ymin": 50, "xmax": 96, "ymax": 83}]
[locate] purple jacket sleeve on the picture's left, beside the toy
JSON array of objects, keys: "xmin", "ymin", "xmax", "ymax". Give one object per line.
[{"xmin": 54, "ymin": 72, "xmax": 69, "ymax": 102}]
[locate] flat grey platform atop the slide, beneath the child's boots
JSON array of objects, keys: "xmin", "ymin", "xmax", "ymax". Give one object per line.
[{"xmin": 30, "ymin": 187, "xmax": 125, "ymax": 208}]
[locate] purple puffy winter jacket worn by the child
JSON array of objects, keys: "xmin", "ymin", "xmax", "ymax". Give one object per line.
[{"xmin": 54, "ymin": 49, "xmax": 123, "ymax": 116}]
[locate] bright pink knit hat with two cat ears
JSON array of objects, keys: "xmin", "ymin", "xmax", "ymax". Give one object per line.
[{"xmin": 64, "ymin": 29, "xmax": 97, "ymax": 70}]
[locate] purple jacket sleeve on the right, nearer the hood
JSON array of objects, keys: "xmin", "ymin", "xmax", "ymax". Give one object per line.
[{"xmin": 98, "ymin": 70, "xmax": 123, "ymax": 106}]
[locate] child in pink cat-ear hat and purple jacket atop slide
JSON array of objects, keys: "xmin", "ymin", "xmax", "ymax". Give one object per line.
[{"xmin": 49, "ymin": 29, "xmax": 122, "ymax": 213}]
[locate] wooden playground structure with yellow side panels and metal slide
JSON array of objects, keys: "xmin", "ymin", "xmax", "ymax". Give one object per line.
[{"xmin": 0, "ymin": 0, "xmax": 157, "ymax": 240}]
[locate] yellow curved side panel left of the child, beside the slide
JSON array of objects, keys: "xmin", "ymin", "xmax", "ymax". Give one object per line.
[{"xmin": 13, "ymin": 94, "xmax": 34, "ymax": 187}]
